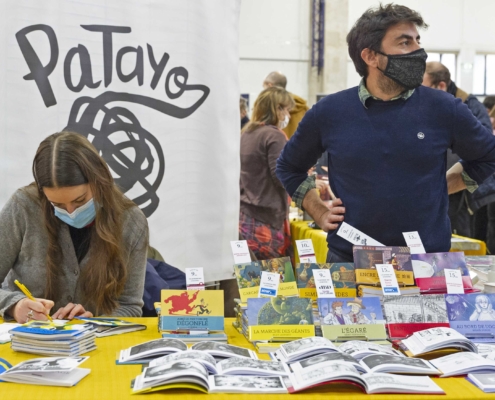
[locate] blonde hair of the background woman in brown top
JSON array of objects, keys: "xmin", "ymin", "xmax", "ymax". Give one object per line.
[{"xmin": 242, "ymin": 86, "xmax": 295, "ymax": 133}]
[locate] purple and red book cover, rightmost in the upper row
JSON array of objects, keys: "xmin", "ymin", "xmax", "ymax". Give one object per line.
[{"xmin": 411, "ymin": 252, "xmax": 473, "ymax": 293}]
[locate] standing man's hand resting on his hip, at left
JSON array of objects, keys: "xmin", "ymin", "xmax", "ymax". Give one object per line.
[{"xmin": 302, "ymin": 189, "xmax": 345, "ymax": 232}]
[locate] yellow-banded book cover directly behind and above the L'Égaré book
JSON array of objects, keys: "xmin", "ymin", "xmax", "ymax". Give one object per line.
[{"xmin": 296, "ymin": 263, "xmax": 356, "ymax": 299}]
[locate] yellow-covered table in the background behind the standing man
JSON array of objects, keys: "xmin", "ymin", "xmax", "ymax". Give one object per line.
[{"xmin": 290, "ymin": 221, "xmax": 486, "ymax": 263}]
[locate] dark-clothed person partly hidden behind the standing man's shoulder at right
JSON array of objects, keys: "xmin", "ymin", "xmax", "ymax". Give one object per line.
[{"xmin": 423, "ymin": 61, "xmax": 495, "ymax": 241}]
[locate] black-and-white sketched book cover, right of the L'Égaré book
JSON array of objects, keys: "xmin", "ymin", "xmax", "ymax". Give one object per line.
[{"xmin": 382, "ymin": 294, "xmax": 448, "ymax": 324}]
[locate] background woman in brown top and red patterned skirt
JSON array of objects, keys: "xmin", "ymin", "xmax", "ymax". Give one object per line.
[{"xmin": 239, "ymin": 86, "xmax": 294, "ymax": 260}]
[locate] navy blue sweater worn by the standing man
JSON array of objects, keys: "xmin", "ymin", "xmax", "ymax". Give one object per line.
[{"xmin": 277, "ymin": 86, "xmax": 495, "ymax": 258}]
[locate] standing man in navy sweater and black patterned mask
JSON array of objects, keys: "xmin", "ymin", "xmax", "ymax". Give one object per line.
[{"xmin": 277, "ymin": 4, "xmax": 495, "ymax": 263}]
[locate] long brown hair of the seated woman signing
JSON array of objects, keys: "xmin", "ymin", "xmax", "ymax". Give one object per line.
[{"xmin": 33, "ymin": 132, "xmax": 140, "ymax": 315}]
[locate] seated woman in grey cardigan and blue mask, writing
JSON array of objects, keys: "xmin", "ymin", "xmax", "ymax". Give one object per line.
[{"xmin": 0, "ymin": 132, "xmax": 148, "ymax": 323}]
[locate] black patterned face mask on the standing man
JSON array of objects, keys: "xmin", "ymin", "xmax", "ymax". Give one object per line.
[{"xmin": 377, "ymin": 49, "xmax": 428, "ymax": 90}]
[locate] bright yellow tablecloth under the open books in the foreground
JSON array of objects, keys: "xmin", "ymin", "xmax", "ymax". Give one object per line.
[{"xmin": 0, "ymin": 318, "xmax": 495, "ymax": 400}]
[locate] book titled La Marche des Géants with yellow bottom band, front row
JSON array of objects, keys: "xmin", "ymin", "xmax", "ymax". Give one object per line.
[{"xmin": 246, "ymin": 296, "xmax": 315, "ymax": 340}]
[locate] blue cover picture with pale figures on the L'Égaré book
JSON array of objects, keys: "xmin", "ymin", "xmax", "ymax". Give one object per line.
[{"xmin": 318, "ymin": 296, "xmax": 386, "ymax": 325}]
